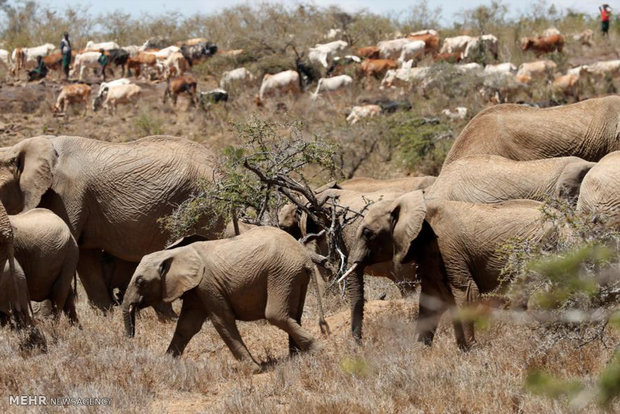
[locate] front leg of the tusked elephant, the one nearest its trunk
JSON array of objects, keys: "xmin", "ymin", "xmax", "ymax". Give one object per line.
[{"xmin": 415, "ymin": 279, "xmax": 454, "ymax": 345}]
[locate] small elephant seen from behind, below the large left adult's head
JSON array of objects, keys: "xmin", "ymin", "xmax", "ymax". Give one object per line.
[{"xmin": 9, "ymin": 208, "xmax": 79, "ymax": 324}]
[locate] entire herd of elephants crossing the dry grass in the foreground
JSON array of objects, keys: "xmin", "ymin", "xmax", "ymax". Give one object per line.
[{"xmin": 0, "ymin": 96, "xmax": 620, "ymax": 369}]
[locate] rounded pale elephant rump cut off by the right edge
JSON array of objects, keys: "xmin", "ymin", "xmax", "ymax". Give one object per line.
[{"xmin": 577, "ymin": 151, "xmax": 620, "ymax": 228}]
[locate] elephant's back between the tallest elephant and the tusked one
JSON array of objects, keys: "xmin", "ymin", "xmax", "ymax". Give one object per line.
[{"xmin": 425, "ymin": 155, "xmax": 596, "ymax": 204}]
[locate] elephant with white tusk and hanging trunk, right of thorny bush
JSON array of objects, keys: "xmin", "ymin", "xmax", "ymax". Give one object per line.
[{"xmin": 345, "ymin": 191, "xmax": 568, "ymax": 349}]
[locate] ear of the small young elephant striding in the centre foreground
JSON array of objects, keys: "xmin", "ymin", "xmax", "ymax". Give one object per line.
[{"xmin": 159, "ymin": 246, "xmax": 204, "ymax": 302}]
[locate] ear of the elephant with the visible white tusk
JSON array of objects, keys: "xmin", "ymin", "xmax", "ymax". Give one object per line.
[{"xmin": 390, "ymin": 191, "xmax": 426, "ymax": 264}]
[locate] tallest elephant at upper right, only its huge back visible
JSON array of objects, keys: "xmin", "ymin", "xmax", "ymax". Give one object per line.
[{"xmin": 443, "ymin": 95, "xmax": 620, "ymax": 168}]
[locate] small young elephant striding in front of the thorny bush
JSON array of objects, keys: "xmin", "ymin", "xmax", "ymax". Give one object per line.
[{"xmin": 122, "ymin": 227, "xmax": 328, "ymax": 371}]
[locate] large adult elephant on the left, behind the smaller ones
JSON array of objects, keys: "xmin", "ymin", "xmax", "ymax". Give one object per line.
[{"xmin": 0, "ymin": 136, "xmax": 222, "ymax": 309}]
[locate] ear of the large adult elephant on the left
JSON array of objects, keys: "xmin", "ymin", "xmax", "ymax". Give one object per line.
[{"xmin": 16, "ymin": 137, "xmax": 58, "ymax": 211}]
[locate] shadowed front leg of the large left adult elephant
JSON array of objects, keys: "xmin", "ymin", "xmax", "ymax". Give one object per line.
[{"xmin": 77, "ymin": 249, "xmax": 114, "ymax": 310}]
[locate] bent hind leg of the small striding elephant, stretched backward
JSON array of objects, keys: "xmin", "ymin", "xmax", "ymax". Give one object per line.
[{"xmin": 265, "ymin": 285, "xmax": 317, "ymax": 351}]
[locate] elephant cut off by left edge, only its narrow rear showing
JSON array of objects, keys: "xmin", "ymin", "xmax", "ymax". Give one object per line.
[{"xmin": 0, "ymin": 203, "xmax": 47, "ymax": 351}]
